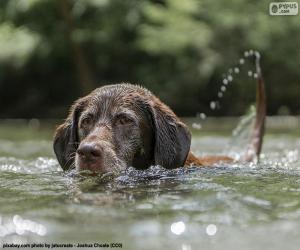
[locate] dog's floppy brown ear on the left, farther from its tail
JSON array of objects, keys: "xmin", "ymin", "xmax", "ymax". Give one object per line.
[{"xmin": 53, "ymin": 97, "xmax": 87, "ymax": 170}]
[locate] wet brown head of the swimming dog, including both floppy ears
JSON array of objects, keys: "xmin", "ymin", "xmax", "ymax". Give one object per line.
[{"xmin": 54, "ymin": 84, "xmax": 191, "ymax": 172}]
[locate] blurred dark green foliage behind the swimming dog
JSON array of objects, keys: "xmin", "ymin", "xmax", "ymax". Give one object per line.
[{"xmin": 0, "ymin": 0, "xmax": 300, "ymax": 118}]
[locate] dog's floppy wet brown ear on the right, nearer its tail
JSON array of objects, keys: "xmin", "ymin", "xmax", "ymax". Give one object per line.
[{"xmin": 151, "ymin": 97, "xmax": 191, "ymax": 169}]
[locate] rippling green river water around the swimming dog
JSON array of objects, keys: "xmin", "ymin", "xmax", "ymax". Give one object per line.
[{"xmin": 0, "ymin": 120, "xmax": 300, "ymax": 250}]
